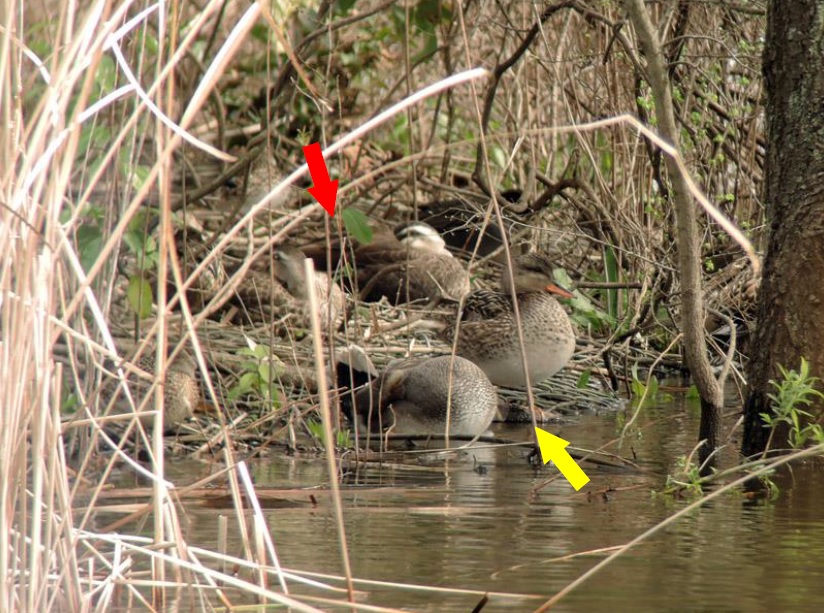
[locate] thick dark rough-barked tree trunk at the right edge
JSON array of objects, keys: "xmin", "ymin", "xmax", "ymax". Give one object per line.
[{"xmin": 742, "ymin": 0, "xmax": 824, "ymax": 455}]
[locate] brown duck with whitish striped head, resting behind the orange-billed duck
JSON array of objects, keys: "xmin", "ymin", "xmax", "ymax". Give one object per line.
[{"xmin": 302, "ymin": 222, "xmax": 471, "ymax": 305}]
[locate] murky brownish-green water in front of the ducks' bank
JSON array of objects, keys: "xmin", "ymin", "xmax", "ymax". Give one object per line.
[{"xmin": 163, "ymin": 394, "xmax": 824, "ymax": 612}]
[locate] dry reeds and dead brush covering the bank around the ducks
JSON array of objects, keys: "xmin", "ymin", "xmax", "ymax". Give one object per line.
[{"xmin": 0, "ymin": 0, "xmax": 764, "ymax": 610}]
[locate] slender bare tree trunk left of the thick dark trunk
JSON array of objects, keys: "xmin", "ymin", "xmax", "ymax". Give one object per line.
[{"xmin": 625, "ymin": 0, "xmax": 723, "ymax": 469}]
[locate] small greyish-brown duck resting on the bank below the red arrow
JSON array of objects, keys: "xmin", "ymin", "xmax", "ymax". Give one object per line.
[{"xmin": 235, "ymin": 245, "xmax": 346, "ymax": 333}]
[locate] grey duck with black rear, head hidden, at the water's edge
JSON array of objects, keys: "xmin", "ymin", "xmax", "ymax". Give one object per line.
[{"xmin": 342, "ymin": 355, "xmax": 498, "ymax": 438}]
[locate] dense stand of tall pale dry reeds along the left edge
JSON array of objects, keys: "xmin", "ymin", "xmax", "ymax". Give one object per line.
[{"xmin": 0, "ymin": 0, "xmax": 332, "ymax": 611}]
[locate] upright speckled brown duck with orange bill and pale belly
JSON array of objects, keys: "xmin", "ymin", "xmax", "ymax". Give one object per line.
[{"xmin": 441, "ymin": 252, "xmax": 575, "ymax": 388}]
